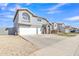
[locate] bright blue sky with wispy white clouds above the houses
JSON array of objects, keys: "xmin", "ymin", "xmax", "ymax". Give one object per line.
[{"xmin": 0, "ymin": 3, "xmax": 79, "ymax": 27}]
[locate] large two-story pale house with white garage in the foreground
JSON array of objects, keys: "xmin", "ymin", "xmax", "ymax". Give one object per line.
[{"xmin": 13, "ymin": 9, "xmax": 49, "ymax": 35}]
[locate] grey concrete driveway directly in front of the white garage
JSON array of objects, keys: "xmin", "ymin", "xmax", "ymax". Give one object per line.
[{"xmin": 22, "ymin": 34, "xmax": 67, "ymax": 48}]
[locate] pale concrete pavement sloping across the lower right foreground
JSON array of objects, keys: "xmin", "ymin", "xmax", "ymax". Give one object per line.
[{"xmin": 31, "ymin": 35, "xmax": 79, "ymax": 56}]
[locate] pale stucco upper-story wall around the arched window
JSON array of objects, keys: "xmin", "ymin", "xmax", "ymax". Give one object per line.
[{"xmin": 18, "ymin": 11, "xmax": 48, "ymax": 25}]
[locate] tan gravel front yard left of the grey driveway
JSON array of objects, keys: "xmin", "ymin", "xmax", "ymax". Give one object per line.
[{"xmin": 0, "ymin": 35, "xmax": 39, "ymax": 56}]
